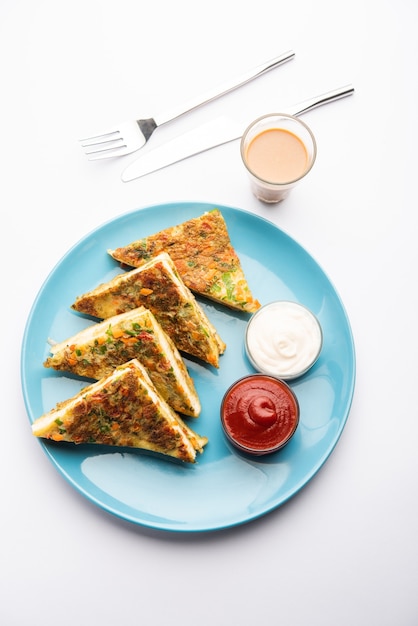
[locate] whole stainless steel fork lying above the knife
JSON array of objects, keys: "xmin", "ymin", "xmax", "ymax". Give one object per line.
[{"xmin": 80, "ymin": 50, "xmax": 295, "ymax": 161}]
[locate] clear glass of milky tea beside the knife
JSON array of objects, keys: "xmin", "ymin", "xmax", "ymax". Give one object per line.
[{"xmin": 241, "ymin": 113, "xmax": 316, "ymax": 203}]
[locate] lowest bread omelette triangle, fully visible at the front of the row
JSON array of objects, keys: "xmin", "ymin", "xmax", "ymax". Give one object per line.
[{"xmin": 32, "ymin": 359, "xmax": 208, "ymax": 463}]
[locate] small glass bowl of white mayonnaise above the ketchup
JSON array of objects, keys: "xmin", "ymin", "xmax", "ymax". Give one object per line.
[{"xmin": 246, "ymin": 301, "xmax": 322, "ymax": 379}]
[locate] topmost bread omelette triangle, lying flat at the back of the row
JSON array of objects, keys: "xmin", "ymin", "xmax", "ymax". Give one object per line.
[{"xmin": 108, "ymin": 209, "xmax": 260, "ymax": 313}]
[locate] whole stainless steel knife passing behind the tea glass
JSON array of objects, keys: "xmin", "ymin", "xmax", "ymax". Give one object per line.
[{"xmin": 121, "ymin": 85, "xmax": 354, "ymax": 182}]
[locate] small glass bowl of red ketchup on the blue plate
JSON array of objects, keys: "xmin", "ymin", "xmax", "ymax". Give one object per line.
[{"xmin": 221, "ymin": 374, "xmax": 299, "ymax": 455}]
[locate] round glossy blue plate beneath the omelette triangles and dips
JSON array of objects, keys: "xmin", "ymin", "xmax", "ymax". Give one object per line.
[{"xmin": 21, "ymin": 203, "xmax": 355, "ymax": 532}]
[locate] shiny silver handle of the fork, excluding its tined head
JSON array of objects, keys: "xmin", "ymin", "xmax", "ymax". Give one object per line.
[{"xmin": 153, "ymin": 50, "xmax": 295, "ymax": 126}]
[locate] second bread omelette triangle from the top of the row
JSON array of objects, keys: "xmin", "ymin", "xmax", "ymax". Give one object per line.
[{"xmin": 72, "ymin": 252, "xmax": 226, "ymax": 367}]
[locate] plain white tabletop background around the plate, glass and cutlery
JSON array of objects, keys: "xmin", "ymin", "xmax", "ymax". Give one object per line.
[{"xmin": 0, "ymin": 0, "xmax": 418, "ymax": 626}]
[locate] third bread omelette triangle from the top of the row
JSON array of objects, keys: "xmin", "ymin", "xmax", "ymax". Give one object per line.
[{"xmin": 44, "ymin": 307, "xmax": 201, "ymax": 417}]
